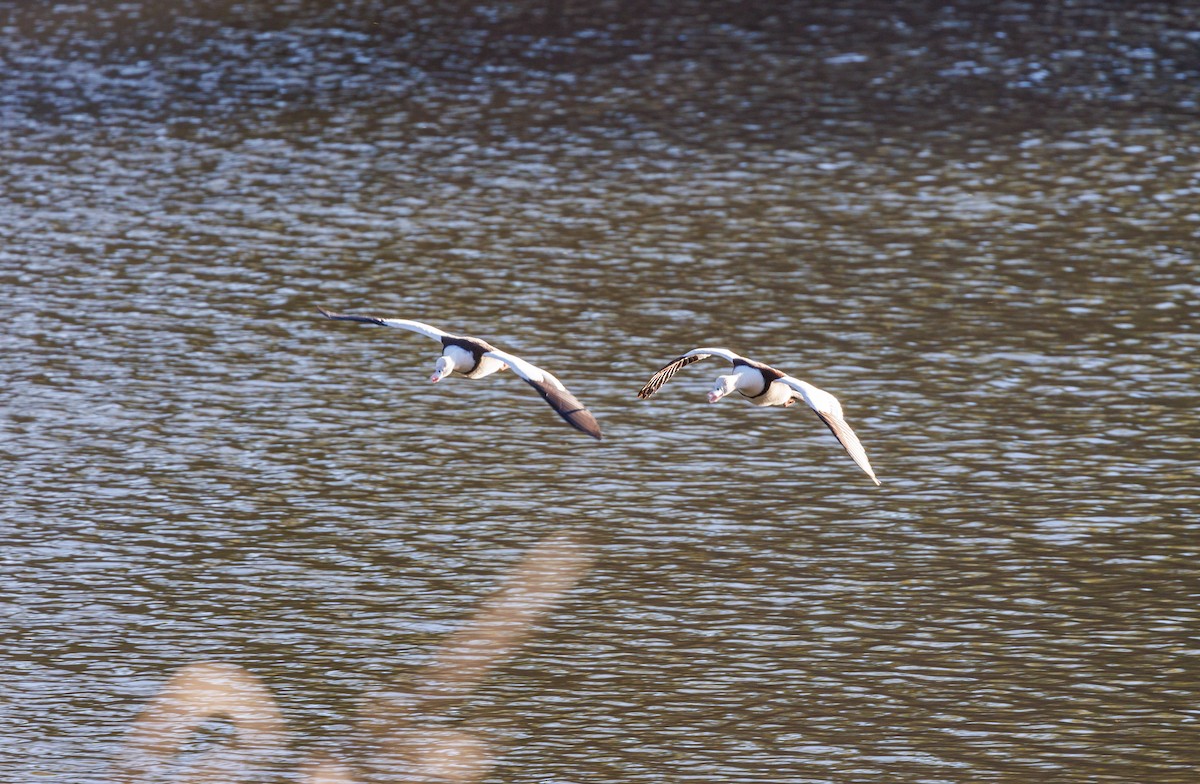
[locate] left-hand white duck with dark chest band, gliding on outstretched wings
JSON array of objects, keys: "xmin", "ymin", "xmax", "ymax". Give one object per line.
[{"xmin": 317, "ymin": 307, "xmax": 600, "ymax": 438}]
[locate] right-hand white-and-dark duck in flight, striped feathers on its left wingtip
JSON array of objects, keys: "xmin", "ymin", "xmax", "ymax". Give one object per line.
[{"xmin": 637, "ymin": 347, "xmax": 880, "ymax": 484}]
